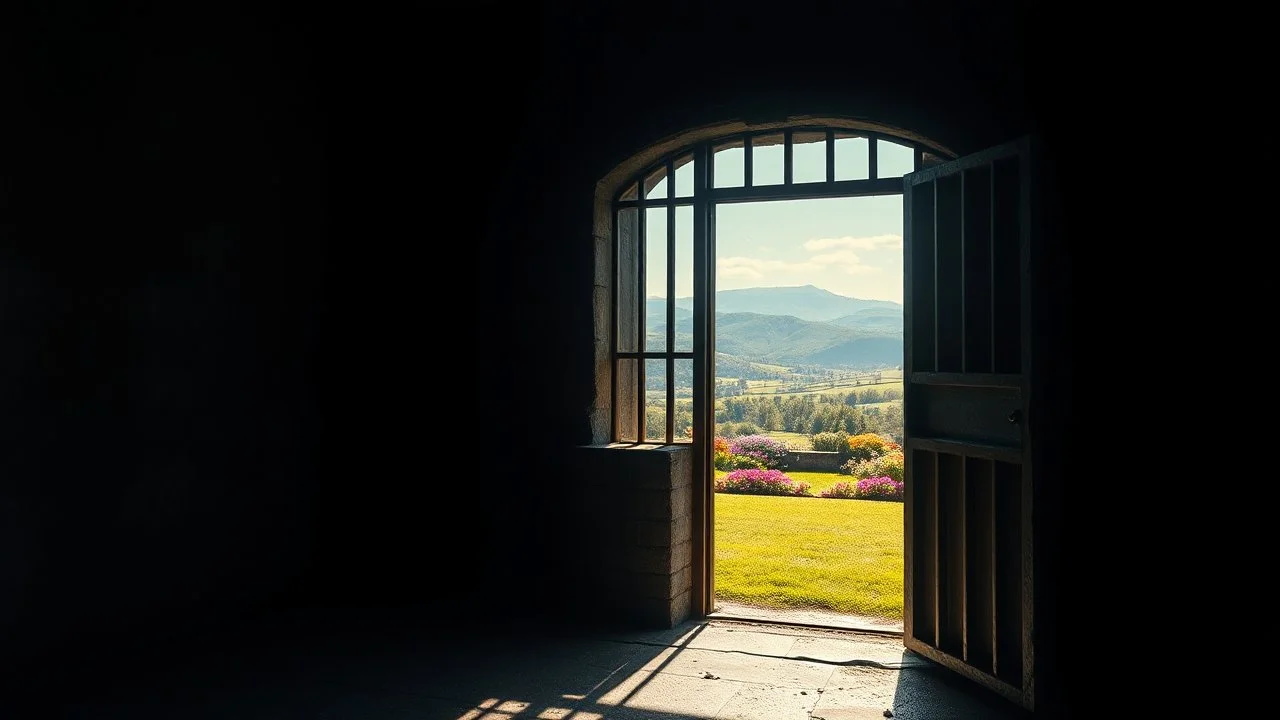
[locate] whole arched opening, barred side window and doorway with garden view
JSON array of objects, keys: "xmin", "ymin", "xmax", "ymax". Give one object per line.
[{"xmin": 609, "ymin": 127, "xmax": 946, "ymax": 632}]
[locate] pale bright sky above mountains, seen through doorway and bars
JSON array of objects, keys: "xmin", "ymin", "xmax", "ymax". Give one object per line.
[{"xmin": 645, "ymin": 138, "xmax": 911, "ymax": 302}]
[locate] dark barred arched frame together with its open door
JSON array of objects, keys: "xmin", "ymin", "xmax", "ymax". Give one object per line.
[{"xmin": 593, "ymin": 118, "xmax": 1034, "ymax": 707}]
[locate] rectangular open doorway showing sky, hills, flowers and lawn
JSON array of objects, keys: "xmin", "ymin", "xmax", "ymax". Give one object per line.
[{"xmin": 713, "ymin": 195, "xmax": 905, "ymax": 632}]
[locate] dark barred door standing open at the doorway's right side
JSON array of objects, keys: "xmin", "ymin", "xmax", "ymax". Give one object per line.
[{"xmin": 902, "ymin": 133, "xmax": 1036, "ymax": 710}]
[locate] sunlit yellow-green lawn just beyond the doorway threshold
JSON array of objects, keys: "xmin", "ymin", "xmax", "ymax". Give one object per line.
[{"xmin": 716, "ymin": 473, "xmax": 902, "ymax": 619}]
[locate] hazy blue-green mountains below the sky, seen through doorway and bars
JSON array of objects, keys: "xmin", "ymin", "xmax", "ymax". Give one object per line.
[{"xmin": 645, "ymin": 284, "xmax": 902, "ymax": 366}]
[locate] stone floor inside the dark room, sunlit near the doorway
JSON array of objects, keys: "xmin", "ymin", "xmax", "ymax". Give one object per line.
[{"xmin": 27, "ymin": 607, "xmax": 1027, "ymax": 720}]
